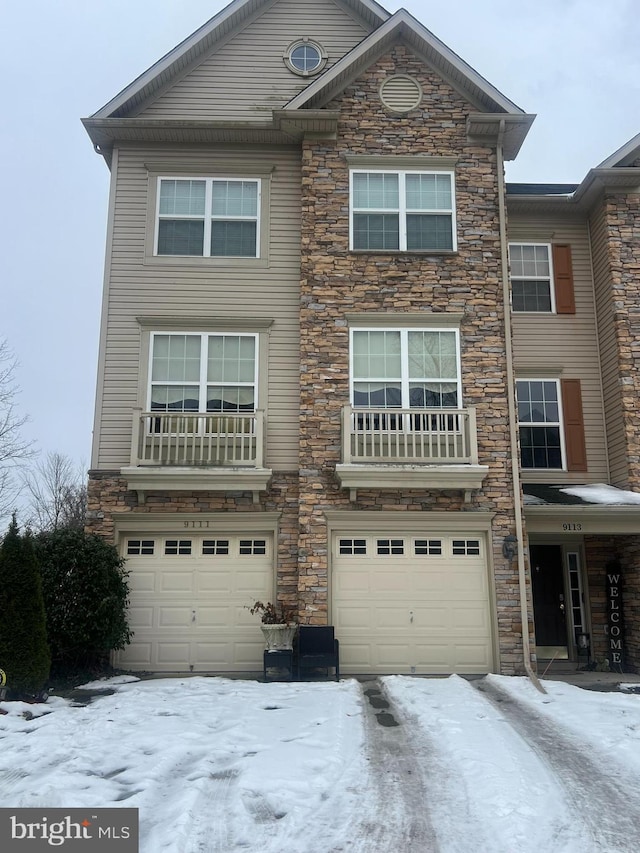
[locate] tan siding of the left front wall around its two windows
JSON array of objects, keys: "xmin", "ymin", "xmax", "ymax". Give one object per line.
[{"xmin": 94, "ymin": 147, "xmax": 301, "ymax": 470}]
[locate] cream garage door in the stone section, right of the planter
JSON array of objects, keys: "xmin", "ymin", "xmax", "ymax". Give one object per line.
[{"xmin": 332, "ymin": 533, "xmax": 493, "ymax": 674}]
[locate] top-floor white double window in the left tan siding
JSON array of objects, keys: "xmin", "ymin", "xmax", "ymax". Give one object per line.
[{"xmin": 154, "ymin": 178, "xmax": 261, "ymax": 258}]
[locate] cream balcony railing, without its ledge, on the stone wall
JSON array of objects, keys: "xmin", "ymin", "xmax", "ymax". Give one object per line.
[{"xmin": 342, "ymin": 406, "xmax": 478, "ymax": 465}]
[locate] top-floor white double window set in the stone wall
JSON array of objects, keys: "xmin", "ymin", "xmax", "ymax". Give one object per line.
[{"xmin": 350, "ymin": 169, "xmax": 456, "ymax": 252}]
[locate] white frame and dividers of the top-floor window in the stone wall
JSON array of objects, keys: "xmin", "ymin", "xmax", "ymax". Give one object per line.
[{"xmin": 349, "ymin": 167, "xmax": 458, "ymax": 255}]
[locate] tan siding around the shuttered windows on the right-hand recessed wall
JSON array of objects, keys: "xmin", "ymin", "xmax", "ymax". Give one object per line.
[{"xmin": 509, "ymin": 213, "xmax": 609, "ymax": 483}]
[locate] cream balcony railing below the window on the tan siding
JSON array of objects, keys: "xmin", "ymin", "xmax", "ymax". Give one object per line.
[{"xmin": 131, "ymin": 409, "xmax": 264, "ymax": 468}]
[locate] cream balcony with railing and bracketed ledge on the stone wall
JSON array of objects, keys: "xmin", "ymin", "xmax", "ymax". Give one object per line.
[{"xmin": 336, "ymin": 406, "xmax": 489, "ymax": 501}]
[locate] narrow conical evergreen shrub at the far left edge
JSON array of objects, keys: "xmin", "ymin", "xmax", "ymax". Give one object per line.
[{"xmin": 0, "ymin": 516, "xmax": 51, "ymax": 698}]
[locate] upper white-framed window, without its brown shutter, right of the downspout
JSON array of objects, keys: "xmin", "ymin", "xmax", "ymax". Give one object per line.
[{"xmin": 509, "ymin": 243, "xmax": 555, "ymax": 313}]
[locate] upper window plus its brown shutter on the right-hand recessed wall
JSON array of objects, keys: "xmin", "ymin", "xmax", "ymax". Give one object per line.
[{"xmin": 509, "ymin": 243, "xmax": 576, "ymax": 314}]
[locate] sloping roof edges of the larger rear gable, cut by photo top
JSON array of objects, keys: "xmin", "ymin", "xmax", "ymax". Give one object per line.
[{"xmin": 91, "ymin": 0, "xmax": 389, "ymax": 119}]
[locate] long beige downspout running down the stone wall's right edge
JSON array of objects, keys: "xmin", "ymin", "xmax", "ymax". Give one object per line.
[{"xmin": 496, "ymin": 119, "xmax": 547, "ymax": 693}]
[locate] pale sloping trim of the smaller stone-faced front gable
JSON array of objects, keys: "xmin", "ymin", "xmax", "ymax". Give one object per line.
[{"xmin": 286, "ymin": 9, "xmax": 525, "ymax": 115}]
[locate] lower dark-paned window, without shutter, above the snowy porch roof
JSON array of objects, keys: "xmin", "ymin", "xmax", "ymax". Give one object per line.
[{"xmin": 516, "ymin": 379, "xmax": 564, "ymax": 468}]
